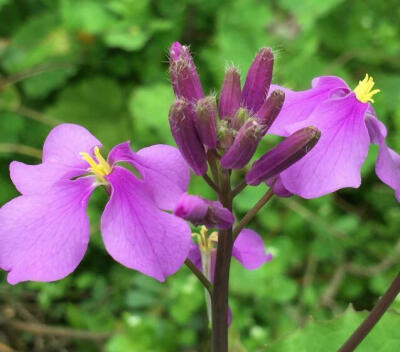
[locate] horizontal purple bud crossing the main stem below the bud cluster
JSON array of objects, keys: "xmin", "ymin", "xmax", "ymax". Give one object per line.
[{"xmin": 174, "ymin": 193, "xmax": 234, "ymax": 229}]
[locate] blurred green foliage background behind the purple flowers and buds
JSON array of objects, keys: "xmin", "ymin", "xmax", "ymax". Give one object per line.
[{"xmin": 0, "ymin": 0, "xmax": 400, "ymax": 352}]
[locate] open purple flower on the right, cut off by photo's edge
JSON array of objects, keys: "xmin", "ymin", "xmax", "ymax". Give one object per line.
[{"xmin": 269, "ymin": 75, "xmax": 400, "ymax": 201}]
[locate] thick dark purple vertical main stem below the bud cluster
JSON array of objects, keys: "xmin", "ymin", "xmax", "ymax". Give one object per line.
[{"xmin": 212, "ymin": 171, "xmax": 233, "ymax": 352}]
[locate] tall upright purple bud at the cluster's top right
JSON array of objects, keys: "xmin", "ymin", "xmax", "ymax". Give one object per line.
[{"xmin": 242, "ymin": 48, "xmax": 274, "ymax": 113}]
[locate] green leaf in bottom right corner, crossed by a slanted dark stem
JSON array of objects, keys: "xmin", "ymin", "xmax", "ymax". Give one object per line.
[{"xmin": 263, "ymin": 309, "xmax": 400, "ymax": 352}]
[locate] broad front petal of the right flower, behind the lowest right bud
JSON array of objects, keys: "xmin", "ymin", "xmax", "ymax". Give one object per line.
[{"xmin": 281, "ymin": 93, "xmax": 370, "ymax": 198}]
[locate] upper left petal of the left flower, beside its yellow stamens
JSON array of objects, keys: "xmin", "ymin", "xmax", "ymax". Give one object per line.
[{"xmin": 43, "ymin": 123, "xmax": 102, "ymax": 169}]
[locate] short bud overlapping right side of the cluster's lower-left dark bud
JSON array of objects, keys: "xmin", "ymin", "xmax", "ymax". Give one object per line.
[{"xmin": 196, "ymin": 96, "xmax": 217, "ymax": 149}]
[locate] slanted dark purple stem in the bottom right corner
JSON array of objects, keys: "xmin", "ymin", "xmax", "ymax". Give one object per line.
[{"xmin": 338, "ymin": 273, "xmax": 400, "ymax": 352}]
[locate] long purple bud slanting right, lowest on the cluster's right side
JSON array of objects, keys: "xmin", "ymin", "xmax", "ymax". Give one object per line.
[{"xmin": 246, "ymin": 127, "xmax": 321, "ymax": 186}]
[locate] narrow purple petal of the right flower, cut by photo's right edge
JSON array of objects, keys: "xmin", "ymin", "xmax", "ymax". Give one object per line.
[{"xmin": 365, "ymin": 112, "xmax": 400, "ymax": 202}]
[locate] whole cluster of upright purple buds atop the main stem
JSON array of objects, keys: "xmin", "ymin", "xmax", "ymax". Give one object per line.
[{"xmin": 169, "ymin": 42, "xmax": 320, "ymax": 185}]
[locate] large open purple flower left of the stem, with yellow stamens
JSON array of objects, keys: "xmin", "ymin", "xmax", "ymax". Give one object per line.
[{"xmin": 0, "ymin": 124, "xmax": 191, "ymax": 284}]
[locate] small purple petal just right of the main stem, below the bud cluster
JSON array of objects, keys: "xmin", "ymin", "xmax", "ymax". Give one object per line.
[{"xmin": 232, "ymin": 229, "xmax": 272, "ymax": 270}]
